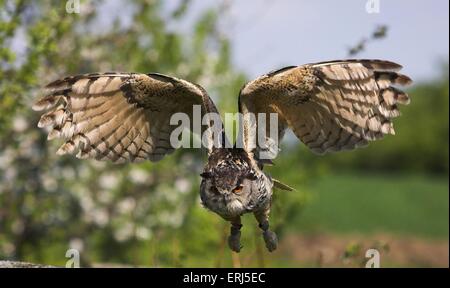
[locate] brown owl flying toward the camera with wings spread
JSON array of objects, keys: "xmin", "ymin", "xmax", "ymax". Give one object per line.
[{"xmin": 33, "ymin": 60, "xmax": 411, "ymax": 252}]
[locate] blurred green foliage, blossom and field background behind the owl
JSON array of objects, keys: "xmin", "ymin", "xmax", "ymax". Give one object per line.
[{"xmin": 0, "ymin": 0, "xmax": 449, "ymax": 267}]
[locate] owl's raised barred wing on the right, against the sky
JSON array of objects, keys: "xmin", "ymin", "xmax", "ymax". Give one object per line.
[{"xmin": 239, "ymin": 60, "xmax": 411, "ymax": 159}]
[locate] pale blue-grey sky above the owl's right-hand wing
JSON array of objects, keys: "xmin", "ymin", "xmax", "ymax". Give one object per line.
[{"xmin": 171, "ymin": 0, "xmax": 449, "ymax": 80}]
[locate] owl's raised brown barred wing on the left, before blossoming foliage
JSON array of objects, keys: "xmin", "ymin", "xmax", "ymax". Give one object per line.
[{"xmin": 33, "ymin": 72, "xmax": 225, "ymax": 163}]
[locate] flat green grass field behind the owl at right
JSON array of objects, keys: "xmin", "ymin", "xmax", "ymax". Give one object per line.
[{"xmin": 288, "ymin": 171, "xmax": 449, "ymax": 239}]
